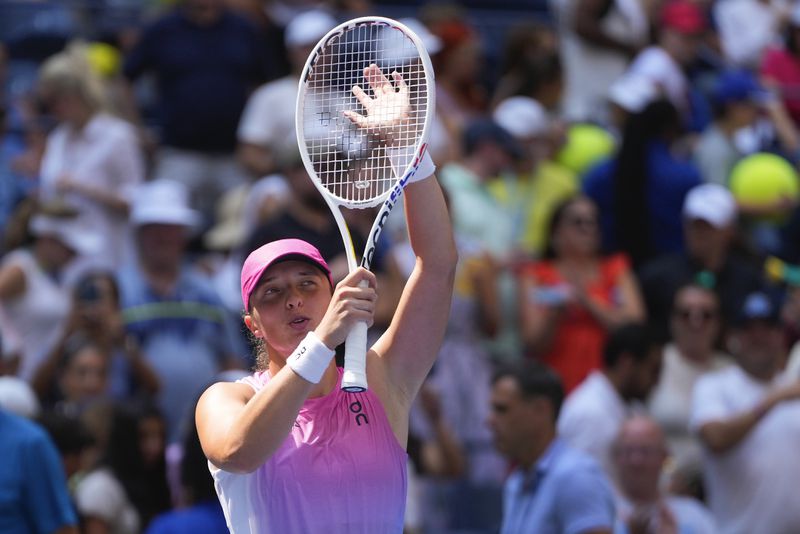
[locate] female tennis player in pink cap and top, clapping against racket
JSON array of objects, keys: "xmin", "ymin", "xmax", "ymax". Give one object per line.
[{"xmin": 196, "ymin": 69, "xmax": 457, "ymax": 534}]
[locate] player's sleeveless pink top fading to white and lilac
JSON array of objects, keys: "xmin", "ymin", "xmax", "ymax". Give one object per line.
[{"xmin": 209, "ymin": 369, "xmax": 407, "ymax": 534}]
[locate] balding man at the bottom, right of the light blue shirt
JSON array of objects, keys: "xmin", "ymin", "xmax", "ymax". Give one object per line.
[{"xmin": 612, "ymin": 416, "xmax": 718, "ymax": 534}]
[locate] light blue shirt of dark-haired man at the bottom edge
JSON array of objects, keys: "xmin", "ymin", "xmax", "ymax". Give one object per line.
[{"xmin": 501, "ymin": 438, "xmax": 615, "ymax": 534}]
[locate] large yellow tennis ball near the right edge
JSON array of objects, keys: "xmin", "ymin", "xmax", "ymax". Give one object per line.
[{"xmin": 728, "ymin": 152, "xmax": 800, "ymax": 206}]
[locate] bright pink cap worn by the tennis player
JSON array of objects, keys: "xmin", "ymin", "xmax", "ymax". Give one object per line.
[{"xmin": 242, "ymin": 239, "xmax": 334, "ymax": 310}]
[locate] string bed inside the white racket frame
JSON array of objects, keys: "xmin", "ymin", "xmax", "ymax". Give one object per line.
[{"xmin": 301, "ymin": 22, "xmax": 428, "ymax": 205}]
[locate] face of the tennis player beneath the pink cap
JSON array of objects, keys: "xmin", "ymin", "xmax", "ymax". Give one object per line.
[{"xmin": 248, "ymin": 261, "xmax": 331, "ymax": 358}]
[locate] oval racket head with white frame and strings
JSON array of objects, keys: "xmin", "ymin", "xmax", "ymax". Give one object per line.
[{"xmin": 295, "ymin": 17, "xmax": 435, "ymax": 208}]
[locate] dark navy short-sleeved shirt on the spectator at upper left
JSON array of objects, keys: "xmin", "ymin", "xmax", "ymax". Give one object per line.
[{"xmin": 124, "ymin": 10, "xmax": 266, "ymax": 153}]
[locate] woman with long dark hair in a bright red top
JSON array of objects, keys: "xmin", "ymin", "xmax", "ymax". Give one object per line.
[{"xmin": 519, "ymin": 196, "xmax": 644, "ymax": 391}]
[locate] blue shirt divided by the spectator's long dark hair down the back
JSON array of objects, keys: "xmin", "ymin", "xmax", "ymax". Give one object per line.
[{"xmin": 583, "ymin": 142, "xmax": 701, "ymax": 255}]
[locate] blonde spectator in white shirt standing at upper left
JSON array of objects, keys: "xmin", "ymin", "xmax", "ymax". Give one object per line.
[{"xmin": 39, "ymin": 45, "xmax": 144, "ymax": 268}]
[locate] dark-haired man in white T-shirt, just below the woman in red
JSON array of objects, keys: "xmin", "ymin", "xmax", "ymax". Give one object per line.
[{"xmin": 558, "ymin": 324, "xmax": 662, "ymax": 473}]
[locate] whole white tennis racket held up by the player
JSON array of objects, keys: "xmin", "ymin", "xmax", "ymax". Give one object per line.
[{"xmin": 295, "ymin": 17, "xmax": 434, "ymax": 392}]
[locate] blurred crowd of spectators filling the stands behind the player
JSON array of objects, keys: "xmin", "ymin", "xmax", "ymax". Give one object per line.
[{"xmin": 0, "ymin": 0, "xmax": 800, "ymax": 534}]
